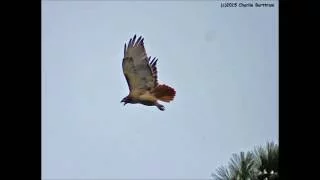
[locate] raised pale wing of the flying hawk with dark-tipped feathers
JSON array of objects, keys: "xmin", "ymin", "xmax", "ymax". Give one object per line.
[{"xmin": 122, "ymin": 35, "xmax": 158, "ymax": 91}]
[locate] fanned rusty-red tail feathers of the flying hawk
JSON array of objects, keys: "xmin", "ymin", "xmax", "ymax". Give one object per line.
[{"xmin": 153, "ymin": 84, "xmax": 176, "ymax": 102}]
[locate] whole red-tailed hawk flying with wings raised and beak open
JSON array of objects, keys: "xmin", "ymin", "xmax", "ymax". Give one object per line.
[{"xmin": 121, "ymin": 35, "xmax": 176, "ymax": 111}]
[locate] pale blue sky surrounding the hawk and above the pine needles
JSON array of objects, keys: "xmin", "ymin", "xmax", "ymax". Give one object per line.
[{"xmin": 42, "ymin": 1, "xmax": 279, "ymax": 179}]
